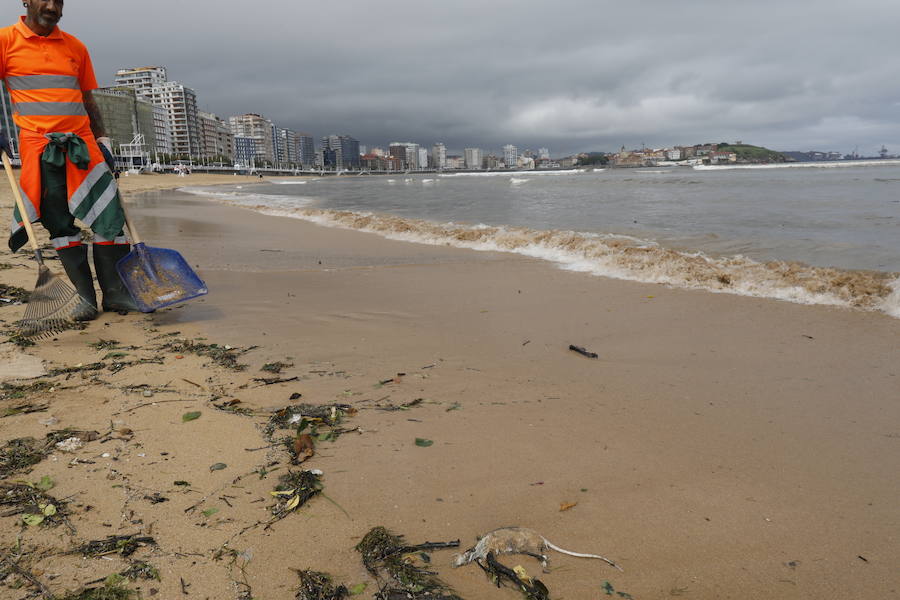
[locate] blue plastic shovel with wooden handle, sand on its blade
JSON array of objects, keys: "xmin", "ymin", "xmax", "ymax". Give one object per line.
[{"xmin": 116, "ymin": 203, "xmax": 209, "ymax": 313}]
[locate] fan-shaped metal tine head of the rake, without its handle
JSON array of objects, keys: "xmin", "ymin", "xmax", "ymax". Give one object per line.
[{"xmin": 16, "ymin": 265, "xmax": 96, "ymax": 338}]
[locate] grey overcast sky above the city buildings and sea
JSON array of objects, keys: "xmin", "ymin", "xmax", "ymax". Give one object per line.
[{"xmin": 42, "ymin": 0, "xmax": 900, "ymax": 156}]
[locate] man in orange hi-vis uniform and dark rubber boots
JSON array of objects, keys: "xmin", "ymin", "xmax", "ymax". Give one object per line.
[{"xmin": 0, "ymin": 0, "xmax": 136, "ymax": 321}]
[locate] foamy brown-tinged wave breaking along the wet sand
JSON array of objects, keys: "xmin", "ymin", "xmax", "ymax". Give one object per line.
[{"xmin": 204, "ymin": 192, "xmax": 900, "ymax": 318}]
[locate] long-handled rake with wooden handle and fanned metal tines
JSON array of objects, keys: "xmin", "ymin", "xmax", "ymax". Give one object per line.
[{"xmin": 2, "ymin": 151, "xmax": 87, "ymax": 338}]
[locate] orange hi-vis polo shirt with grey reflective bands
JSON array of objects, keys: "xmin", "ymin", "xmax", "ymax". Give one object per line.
[{"xmin": 0, "ymin": 17, "xmax": 97, "ymax": 135}]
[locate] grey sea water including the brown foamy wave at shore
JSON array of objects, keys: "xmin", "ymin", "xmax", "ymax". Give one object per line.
[{"xmin": 183, "ymin": 161, "xmax": 900, "ymax": 318}]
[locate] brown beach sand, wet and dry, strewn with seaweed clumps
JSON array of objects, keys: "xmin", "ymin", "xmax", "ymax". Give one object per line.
[{"xmin": 0, "ymin": 175, "xmax": 900, "ymax": 600}]
